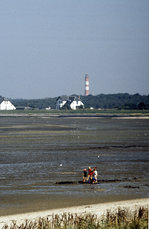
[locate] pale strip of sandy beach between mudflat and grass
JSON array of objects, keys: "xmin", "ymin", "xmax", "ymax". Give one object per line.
[{"xmin": 0, "ymin": 198, "xmax": 149, "ymax": 228}]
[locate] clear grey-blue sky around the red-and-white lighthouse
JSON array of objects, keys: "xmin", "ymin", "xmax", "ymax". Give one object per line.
[{"xmin": 0, "ymin": 0, "xmax": 149, "ymax": 99}]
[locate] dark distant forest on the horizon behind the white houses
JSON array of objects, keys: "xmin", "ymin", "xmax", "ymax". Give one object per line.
[{"xmin": 10, "ymin": 93, "xmax": 149, "ymax": 110}]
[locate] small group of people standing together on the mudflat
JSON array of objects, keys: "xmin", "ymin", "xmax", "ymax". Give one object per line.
[{"xmin": 83, "ymin": 167, "xmax": 98, "ymax": 184}]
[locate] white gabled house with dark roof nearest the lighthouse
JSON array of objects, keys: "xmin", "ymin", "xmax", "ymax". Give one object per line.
[{"xmin": 56, "ymin": 96, "xmax": 84, "ymax": 110}]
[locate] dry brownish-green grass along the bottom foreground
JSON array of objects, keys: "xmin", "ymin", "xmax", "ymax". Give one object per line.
[{"xmin": 3, "ymin": 207, "xmax": 148, "ymax": 229}]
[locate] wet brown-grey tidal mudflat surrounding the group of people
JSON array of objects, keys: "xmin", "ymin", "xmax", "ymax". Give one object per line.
[{"xmin": 0, "ymin": 115, "xmax": 149, "ymax": 215}]
